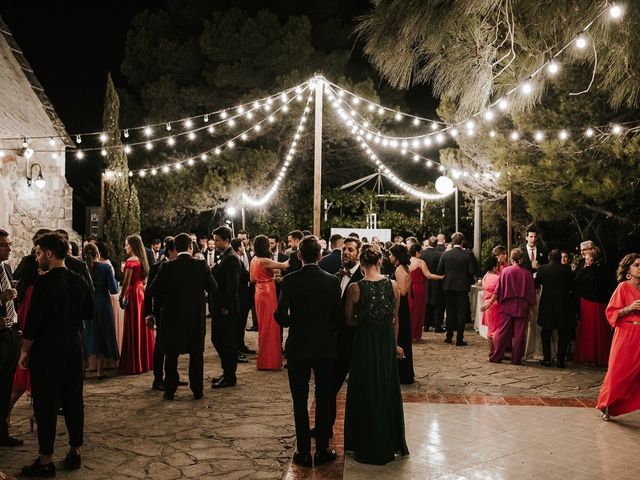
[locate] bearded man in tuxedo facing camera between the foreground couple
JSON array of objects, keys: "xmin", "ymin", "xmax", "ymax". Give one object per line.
[{"xmin": 329, "ymin": 237, "xmax": 362, "ymax": 435}]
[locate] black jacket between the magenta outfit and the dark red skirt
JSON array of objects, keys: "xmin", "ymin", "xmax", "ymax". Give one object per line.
[{"xmin": 535, "ymin": 263, "xmax": 576, "ymax": 330}]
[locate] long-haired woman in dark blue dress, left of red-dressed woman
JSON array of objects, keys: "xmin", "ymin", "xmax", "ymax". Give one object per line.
[{"xmin": 83, "ymin": 243, "xmax": 119, "ymax": 380}]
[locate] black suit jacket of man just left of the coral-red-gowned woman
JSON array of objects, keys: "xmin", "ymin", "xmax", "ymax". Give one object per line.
[{"xmin": 209, "ymin": 247, "xmax": 242, "ymax": 315}]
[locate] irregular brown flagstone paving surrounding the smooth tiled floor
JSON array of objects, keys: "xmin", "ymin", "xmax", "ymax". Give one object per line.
[{"xmin": 0, "ymin": 324, "xmax": 604, "ymax": 479}]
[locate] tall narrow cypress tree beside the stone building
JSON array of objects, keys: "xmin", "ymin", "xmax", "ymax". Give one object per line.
[{"xmin": 102, "ymin": 74, "xmax": 140, "ymax": 265}]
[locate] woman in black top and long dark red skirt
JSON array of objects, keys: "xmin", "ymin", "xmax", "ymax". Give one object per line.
[{"xmin": 574, "ymin": 249, "xmax": 613, "ymax": 367}]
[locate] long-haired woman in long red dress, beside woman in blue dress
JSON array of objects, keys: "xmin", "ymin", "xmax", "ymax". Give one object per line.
[{"xmin": 120, "ymin": 235, "xmax": 154, "ymax": 375}]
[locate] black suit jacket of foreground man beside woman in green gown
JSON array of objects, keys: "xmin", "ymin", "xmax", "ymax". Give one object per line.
[{"xmin": 275, "ymin": 265, "xmax": 343, "ymax": 359}]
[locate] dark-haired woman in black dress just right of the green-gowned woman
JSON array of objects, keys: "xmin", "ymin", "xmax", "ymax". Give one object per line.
[{"xmin": 389, "ymin": 243, "xmax": 415, "ymax": 385}]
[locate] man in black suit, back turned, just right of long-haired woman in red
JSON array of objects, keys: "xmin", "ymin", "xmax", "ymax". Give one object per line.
[{"xmin": 149, "ymin": 233, "xmax": 218, "ymax": 400}]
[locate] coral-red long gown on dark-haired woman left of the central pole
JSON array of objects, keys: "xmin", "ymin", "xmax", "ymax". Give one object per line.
[{"xmin": 249, "ymin": 257, "xmax": 282, "ymax": 370}]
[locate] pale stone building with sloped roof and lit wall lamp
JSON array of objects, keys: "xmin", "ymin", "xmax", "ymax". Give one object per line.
[{"xmin": 0, "ymin": 17, "xmax": 73, "ymax": 266}]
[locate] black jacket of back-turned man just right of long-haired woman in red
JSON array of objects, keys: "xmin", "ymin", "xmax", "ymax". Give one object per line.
[{"xmin": 149, "ymin": 255, "xmax": 218, "ymax": 353}]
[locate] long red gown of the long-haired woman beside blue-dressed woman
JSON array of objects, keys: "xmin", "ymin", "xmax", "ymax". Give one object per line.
[{"xmin": 120, "ymin": 259, "xmax": 154, "ymax": 375}]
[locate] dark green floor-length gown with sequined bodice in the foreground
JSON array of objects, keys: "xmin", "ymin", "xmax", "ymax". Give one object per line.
[{"xmin": 344, "ymin": 278, "xmax": 409, "ymax": 465}]
